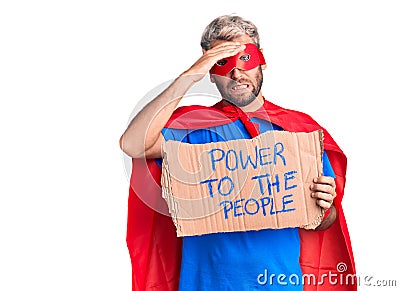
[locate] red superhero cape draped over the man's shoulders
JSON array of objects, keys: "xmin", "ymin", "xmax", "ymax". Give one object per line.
[{"xmin": 127, "ymin": 101, "xmax": 357, "ymax": 291}]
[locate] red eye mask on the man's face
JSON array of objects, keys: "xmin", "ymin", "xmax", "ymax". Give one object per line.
[{"xmin": 210, "ymin": 43, "xmax": 265, "ymax": 76}]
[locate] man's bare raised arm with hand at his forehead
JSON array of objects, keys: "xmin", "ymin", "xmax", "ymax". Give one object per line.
[{"xmin": 120, "ymin": 42, "xmax": 244, "ymax": 158}]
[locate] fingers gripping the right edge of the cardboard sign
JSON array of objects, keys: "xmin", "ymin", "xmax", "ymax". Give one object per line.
[{"xmin": 310, "ymin": 176, "xmax": 336, "ymax": 209}]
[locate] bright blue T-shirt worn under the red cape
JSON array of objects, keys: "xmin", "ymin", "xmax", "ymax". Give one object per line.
[{"xmin": 159, "ymin": 118, "xmax": 334, "ymax": 291}]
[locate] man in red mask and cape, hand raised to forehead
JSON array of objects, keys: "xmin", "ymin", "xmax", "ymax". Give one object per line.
[{"xmin": 120, "ymin": 16, "xmax": 355, "ymax": 290}]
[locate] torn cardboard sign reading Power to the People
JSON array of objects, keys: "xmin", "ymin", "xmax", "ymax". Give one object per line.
[{"xmin": 161, "ymin": 130, "xmax": 324, "ymax": 236}]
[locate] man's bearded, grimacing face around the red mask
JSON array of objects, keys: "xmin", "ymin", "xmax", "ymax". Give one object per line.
[{"xmin": 211, "ymin": 35, "xmax": 263, "ymax": 107}]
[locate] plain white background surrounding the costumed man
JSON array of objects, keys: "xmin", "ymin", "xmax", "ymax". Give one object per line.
[{"xmin": 0, "ymin": 0, "xmax": 400, "ymax": 291}]
